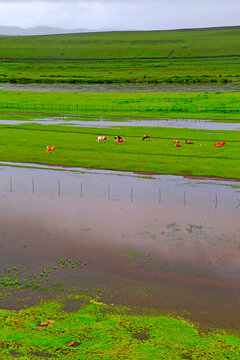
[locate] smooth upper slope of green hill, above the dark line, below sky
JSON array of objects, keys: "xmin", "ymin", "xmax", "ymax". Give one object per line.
[{"xmin": 0, "ymin": 27, "xmax": 240, "ymax": 59}]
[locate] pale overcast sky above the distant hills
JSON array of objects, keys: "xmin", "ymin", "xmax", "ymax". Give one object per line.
[{"xmin": 0, "ymin": 0, "xmax": 240, "ymax": 30}]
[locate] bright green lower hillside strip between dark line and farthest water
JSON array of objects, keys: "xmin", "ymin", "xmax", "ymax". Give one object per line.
[{"xmin": 0, "ymin": 57, "xmax": 240, "ymax": 85}]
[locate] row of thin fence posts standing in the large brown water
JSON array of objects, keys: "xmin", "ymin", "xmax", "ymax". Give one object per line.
[{"xmin": 0, "ymin": 176, "xmax": 240, "ymax": 211}]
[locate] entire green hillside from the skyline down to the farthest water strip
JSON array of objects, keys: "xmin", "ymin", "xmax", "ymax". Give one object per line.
[{"xmin": 0, "ymin": 27, "xmax": 240, "ymax": 84}]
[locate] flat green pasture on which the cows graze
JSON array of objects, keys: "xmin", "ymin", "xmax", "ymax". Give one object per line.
[{"xmin": 0, "ymin": 123, "xmax": 240, "ymax": 179}]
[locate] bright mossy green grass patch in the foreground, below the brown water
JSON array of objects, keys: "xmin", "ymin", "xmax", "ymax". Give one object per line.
[{"xmin": 0, "ymin": 297, "xmax": 240, "ymax": 360}]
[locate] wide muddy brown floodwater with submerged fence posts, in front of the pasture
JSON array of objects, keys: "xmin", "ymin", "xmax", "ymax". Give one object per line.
[{"xmin": 0, "ymin": 166, "xmax": 240, "ymax": 330}]
